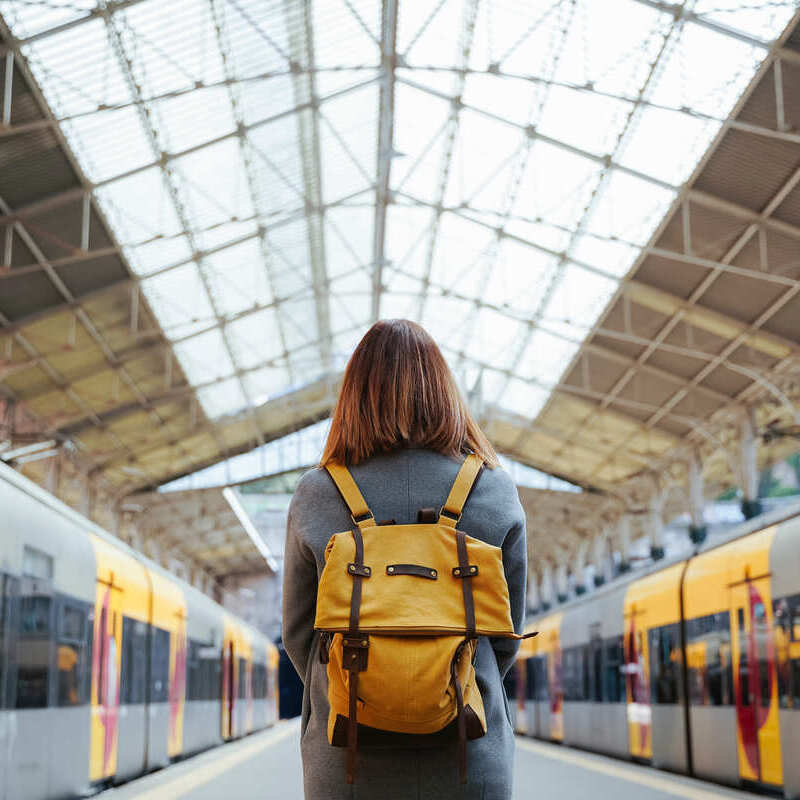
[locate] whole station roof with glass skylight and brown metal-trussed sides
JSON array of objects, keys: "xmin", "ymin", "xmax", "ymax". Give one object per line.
[{"xmin": 0, "ymin": 0, "xmax": 800, "ymax": 494}]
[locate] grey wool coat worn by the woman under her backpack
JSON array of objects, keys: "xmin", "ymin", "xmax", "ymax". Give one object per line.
[{"xmin": 283, "ymin": 448, "xmax": 527, "ymax": 800}]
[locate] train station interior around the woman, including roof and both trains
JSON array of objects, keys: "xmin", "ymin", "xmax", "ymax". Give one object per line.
[{"xmin": 0, "ymin": 0, "xmax": 800, "ymax": 800}]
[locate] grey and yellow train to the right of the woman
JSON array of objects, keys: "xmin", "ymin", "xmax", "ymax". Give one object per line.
[{"xmin": 506, "ymin": 505, "xmax": 800, "ymax": 800}]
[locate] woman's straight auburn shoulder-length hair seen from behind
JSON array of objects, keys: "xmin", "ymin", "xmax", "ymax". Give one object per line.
[{"xmin": 320, "ymin": 319, "xmax": 498, "ymax": 467}]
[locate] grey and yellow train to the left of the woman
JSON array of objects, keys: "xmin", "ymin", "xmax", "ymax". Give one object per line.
[{"xmin": 0, "ymin": 464, "xmax": 279, "ymax": 800}]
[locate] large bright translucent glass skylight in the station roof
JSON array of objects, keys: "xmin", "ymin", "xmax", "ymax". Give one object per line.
[{"xmin": 0, "ymin": 0, "xmax": 795, "ymax": 432}]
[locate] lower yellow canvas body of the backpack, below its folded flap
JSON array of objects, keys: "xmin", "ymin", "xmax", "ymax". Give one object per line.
[{"xmin": 328, "ymin": 633, "xmax": 486, "ymax": 743}]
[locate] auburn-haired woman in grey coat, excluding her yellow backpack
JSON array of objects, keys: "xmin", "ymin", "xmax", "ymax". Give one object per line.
[{"xmin": 283, "ymin": 320, "xmax": 527, "ymax": 800}]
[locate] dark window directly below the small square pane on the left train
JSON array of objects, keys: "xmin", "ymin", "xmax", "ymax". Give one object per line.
[{"xmin": 15, "ymin": 594, "xmax": 52, "ymax": 708}]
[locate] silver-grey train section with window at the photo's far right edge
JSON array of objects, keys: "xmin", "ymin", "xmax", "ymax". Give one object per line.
[{"xmin": 770, "ymin": 517, "xmax": 800, "ymax": 800}]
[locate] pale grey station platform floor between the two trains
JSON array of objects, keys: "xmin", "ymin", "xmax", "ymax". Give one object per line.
[{"xmin": 97, "ymin": 720, "xmax": 763, "ymax": 800}]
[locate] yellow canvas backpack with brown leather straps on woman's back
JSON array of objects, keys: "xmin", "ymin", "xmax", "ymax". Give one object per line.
[{"xmin": 314, "ymin": 454, "xmax": 536, "ymax": 783}]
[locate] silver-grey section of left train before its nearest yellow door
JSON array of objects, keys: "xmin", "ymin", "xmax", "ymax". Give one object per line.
[{"xmin": 0, "ymin": 466, "xmax": 95, "ymax": 800}]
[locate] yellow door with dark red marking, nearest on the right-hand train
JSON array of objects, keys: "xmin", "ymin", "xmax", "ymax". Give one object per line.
[{"xmin": 730, "ymin": 576, "xmax": 783, "ymax": 786}]
